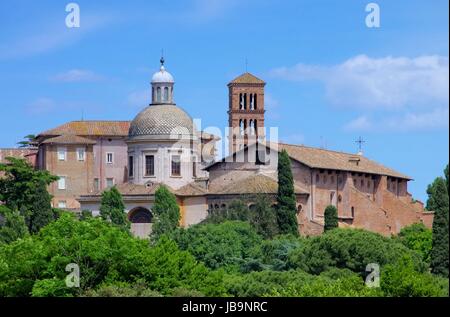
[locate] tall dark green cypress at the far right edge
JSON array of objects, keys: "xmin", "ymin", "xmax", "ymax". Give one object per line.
[{"xmin": 427, "ymin": 177, "xmax": 449, "ymax": 277}]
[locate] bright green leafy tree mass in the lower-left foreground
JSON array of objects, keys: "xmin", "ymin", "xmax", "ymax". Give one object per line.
[{"xmin": 0, "ymin": 214, "xmax": 223, "ymax": 296}]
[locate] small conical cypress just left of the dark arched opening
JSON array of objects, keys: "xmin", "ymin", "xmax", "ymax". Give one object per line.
[{"xmin": 100, "ymin": 186, "xmax": 130, "ymax": 230}]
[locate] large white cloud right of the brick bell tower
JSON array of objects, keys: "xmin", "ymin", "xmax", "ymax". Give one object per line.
[{"xmin": 271, "ymin": 55, "xmax": 449, "ymax": 109}]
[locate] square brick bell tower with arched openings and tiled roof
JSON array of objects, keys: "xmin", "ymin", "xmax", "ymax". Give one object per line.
[{"xmin": 228, "ymin": 73, "xmax": 266, "ymax": 154}]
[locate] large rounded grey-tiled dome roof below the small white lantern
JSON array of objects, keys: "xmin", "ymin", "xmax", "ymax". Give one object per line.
[{"xmin": 128, "ymin": 105, "xmax": 194, "ymax": 138}]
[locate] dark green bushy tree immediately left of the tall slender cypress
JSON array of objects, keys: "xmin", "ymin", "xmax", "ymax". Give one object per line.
[{"xmin": 250, "ymin": 195, "xmax": 278, "ymax": 239}]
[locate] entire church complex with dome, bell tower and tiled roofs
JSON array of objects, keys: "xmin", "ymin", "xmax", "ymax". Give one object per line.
[{"xmin": 27, "ymin": 60, "xmax": 433, "ymax": 237}]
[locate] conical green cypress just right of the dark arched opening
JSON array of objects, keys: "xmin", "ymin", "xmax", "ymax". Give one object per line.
[{"xmin": 152, "ymin": 185, "xmax": 181, "ymax": 239}]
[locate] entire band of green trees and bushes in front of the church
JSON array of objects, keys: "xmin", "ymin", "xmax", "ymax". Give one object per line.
[{"xmin": 0, "ymin": 161, "xmax": 449, "ymax": 297}]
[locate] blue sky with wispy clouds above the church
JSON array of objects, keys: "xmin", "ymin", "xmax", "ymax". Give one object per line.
[{"xmin": 0, "ymin": 0, "xmax": 449, "ymax": 200}]
